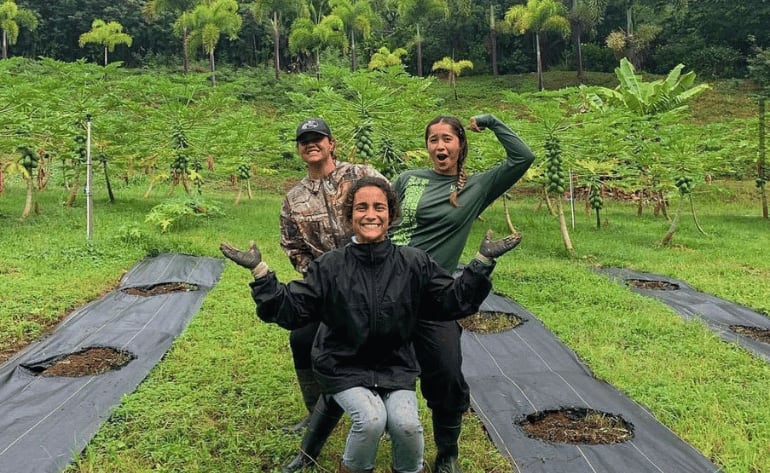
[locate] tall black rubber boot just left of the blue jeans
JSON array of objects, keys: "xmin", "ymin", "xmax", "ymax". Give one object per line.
[{"xmin": 281, "ymin": 395, "xmax": 344, "ymax": 473}]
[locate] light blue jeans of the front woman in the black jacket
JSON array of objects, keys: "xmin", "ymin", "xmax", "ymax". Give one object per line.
[{"xmin": 334, "ymin": 387, "xmax": 425, "ymax": 473}]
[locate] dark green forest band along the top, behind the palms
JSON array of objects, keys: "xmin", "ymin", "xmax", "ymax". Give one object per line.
[{"xmin": 6, "ymin": 0, "xmax": 770, "ymax": 78}]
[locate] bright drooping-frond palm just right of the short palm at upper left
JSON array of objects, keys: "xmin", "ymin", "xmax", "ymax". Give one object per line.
[{"xmin": 178, "ymin": 0, "xmax": 243, "ymax": 86}]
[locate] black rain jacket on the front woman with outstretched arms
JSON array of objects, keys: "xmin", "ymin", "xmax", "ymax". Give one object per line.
[{"xmin": 250, "ymin": 239, "xmax": 494, "ymax": 394}]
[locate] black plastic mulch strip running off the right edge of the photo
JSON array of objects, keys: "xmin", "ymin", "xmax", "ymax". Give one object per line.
[{"xmin": 597, "ymin": 268, "xmax": 770, "ymax": 362}]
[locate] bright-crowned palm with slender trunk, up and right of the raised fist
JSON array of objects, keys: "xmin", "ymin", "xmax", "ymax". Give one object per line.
[{"xmin": 505, "ymin": 0, "xmax": 570, "ymax": 90}]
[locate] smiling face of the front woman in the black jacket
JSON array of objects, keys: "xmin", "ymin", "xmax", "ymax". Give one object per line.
[{"xmin": 350, "ymin": 186, "xmax": 390, "ymax": 243}]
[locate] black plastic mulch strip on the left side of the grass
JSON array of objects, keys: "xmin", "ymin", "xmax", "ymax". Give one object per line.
[{"xmin": 0, "ymin": 254, "xmax": 224, "ymax": 473}]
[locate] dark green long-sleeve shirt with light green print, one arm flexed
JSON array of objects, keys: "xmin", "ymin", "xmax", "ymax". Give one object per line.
[{"xmin": 391, "ymin": 114, "xmax": 535, "ymax": 271}]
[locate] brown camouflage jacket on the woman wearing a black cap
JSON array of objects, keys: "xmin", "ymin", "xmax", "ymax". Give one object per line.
[{"xmin": 281, "ymin": 161, "xmax": 383, "ymax": 274}]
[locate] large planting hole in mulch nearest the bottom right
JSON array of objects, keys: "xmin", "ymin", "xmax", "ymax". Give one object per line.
[{"xmin": 518, "ymin": 407, "xmax": 634, "ymax": 445}]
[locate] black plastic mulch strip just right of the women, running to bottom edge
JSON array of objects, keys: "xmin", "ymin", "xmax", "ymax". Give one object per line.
[{"xmin": 462, "ymin": 294, "xmax": 720, "ymax": 473}]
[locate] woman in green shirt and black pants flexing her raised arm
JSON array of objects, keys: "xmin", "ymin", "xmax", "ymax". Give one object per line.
[{"xmin": 391, "ymin": 114, "xmax": 535, "ymax": 473}]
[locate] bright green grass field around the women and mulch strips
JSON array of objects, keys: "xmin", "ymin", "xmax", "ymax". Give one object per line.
[{"xmin": 0, "ymin": 67, "xmax": 770, "ymax": 473}]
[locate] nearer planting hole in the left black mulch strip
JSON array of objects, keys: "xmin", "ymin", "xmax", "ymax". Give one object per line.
[{"xmin": 24, "ymin": 347, "xmax": 135, "ymax": 378}]
